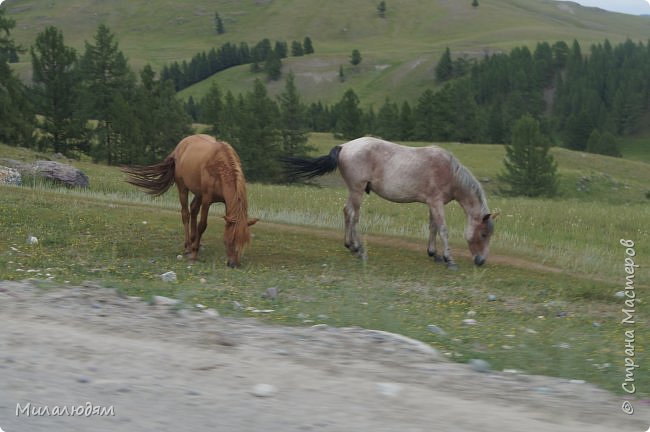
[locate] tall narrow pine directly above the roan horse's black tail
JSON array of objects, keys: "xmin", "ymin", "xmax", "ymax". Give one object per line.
[{"xmin": 278, "ymin": 72, "xmax": 311, "ymax": 156}]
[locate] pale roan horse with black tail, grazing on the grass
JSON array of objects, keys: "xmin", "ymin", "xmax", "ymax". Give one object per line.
[{"xmin": 283, "ymin": 137, "xmax": 495, "ymax": 269}]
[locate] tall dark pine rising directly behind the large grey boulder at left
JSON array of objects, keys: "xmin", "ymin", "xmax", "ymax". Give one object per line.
[{"xmin": 31, "ymin": 26, "xmax": 83, "ymax": 155}]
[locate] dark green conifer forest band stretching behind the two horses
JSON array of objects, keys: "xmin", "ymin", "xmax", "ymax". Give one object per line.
[{"xmin": 0, "ymin": 9, "xmax": 650, "ymax": 181}]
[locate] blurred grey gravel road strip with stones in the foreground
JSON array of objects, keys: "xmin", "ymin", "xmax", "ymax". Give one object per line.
[{"xmin": 0, "ymin": 282, "xmax": 650, "ymax": 432}]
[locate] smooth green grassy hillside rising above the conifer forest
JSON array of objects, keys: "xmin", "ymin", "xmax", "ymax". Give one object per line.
[{"xmin": 3, "ymin": 0, "xmax": 650, "ymax": 104}]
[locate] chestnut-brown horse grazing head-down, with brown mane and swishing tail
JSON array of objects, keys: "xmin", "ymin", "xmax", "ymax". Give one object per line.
[{"xmin": 122, "ymin": 135, "xmax": 257, "ymax": 267}]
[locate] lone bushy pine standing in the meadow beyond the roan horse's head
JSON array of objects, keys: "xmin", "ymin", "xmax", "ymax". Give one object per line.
[{"xmin": 499, "ymin": 115, "xmax": 557, "ymax": 197}]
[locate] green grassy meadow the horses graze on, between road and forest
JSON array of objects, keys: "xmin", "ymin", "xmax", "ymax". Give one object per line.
[{"xmin": 0, "ymin": 134, "xmax": 650, "ymax": 397}]
